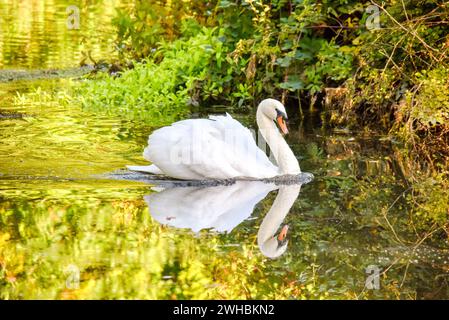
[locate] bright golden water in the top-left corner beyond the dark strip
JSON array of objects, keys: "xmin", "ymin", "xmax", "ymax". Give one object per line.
[{"xmin": 0, "ymin": 0, "xmax": 122, "ymax": 69}]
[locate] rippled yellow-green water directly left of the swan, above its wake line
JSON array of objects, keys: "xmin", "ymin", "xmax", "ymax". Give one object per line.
[{"xmin": 0, "ymin": 80, "xmax": 150, "ymax": 178}]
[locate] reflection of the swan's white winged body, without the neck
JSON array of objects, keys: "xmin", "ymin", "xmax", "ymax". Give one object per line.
[{"xmin": 145, "ymin": 181, "xmax": 277, "ymax": 232}]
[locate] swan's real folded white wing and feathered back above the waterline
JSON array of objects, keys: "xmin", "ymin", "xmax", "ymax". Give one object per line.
[{"xmin": 144, "ymin": 115, "xmax": 278, "ymax": 179}]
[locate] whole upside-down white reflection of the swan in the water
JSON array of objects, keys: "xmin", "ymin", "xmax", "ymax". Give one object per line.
[{"xmin": 144, "ymin": 173, "xmax": 312, "ymax": 258}]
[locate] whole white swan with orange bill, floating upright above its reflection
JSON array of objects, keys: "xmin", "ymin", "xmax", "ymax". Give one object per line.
[{"xmin": 127, "ymin": 99, "xmax": 301, "ymax": 180}]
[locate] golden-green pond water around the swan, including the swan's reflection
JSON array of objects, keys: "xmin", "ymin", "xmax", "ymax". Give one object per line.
[{"xmin": 0, "ymin": 1, "xmax": 449, "ymax": 299}]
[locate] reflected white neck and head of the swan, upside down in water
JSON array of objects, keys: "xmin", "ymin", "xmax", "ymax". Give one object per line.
[{"xmin": 257, "ymin": 185, "xmax": 301, "ymax": 258}]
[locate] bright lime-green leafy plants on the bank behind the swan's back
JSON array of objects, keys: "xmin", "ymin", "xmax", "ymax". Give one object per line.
[{"xmin": 76, "ymin": 28, "xmax": 220, "ymax": 125}]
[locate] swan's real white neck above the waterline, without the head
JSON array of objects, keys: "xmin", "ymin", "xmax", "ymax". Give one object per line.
[{"xmin": 257, "ymin": 108, "xmax": 301, "ymax": 174}]
